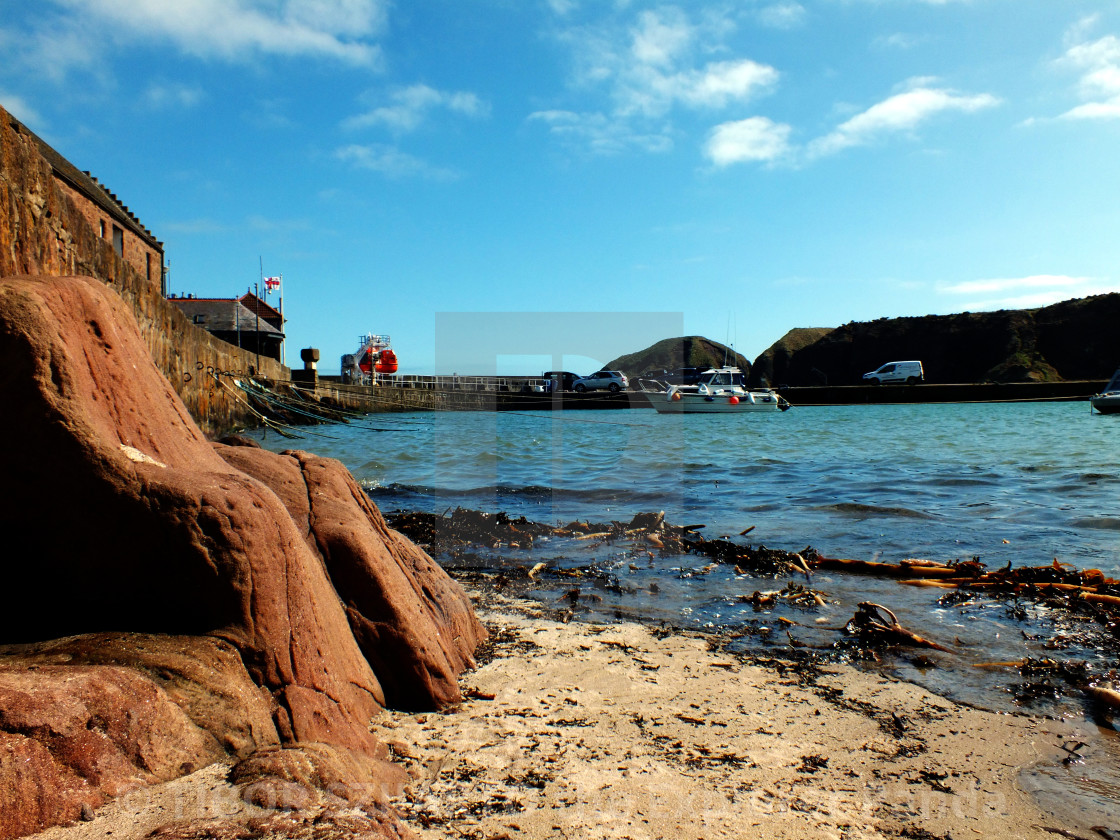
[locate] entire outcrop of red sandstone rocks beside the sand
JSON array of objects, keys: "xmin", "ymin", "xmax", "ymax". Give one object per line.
[{"xmin": 0, "ymin": 277, "xmax": 486, "ymax": 838}]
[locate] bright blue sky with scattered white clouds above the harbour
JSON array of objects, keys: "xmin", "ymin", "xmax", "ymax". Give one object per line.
[{"xmin": 0, "ymin": 0, "xmax": 1120, "ymax": 373}]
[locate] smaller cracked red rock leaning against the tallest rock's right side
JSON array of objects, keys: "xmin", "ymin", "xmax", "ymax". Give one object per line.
[{"xmin": 215, "ymin": 445, "xmax": 486, "ymax": 712}]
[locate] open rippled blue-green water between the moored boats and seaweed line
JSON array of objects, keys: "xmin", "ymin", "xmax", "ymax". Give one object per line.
[{"xmin": 256, "ymin": 402, "xmax": 1120, "ymax": 576}]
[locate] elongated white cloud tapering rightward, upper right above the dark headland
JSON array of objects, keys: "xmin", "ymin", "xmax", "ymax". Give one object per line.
[{"xmin": 808, "ymin": 78, "xmax": 999, "ymax": 158}]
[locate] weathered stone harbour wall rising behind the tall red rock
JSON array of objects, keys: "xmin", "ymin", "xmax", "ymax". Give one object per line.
[{"xmin": 0, "ymin": 101, "xmax": 282, "ymax": 435}]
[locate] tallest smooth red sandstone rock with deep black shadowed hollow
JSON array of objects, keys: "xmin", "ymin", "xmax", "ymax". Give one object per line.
[{"xmin": 0, "ymin": 278, "xmax": 384, "ymax": 755}]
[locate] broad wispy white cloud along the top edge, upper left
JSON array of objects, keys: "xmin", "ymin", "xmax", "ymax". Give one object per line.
[{"xmin": 36, "ymin": 0, "xmax": 385, "ymax": 67}]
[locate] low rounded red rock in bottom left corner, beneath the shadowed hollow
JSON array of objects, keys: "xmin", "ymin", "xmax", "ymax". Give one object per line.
[{"xmin": 0, "ymin": 634, "xmax": 279, "ymax": 838}]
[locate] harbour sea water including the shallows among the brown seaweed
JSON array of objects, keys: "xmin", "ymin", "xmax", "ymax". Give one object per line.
[{"xmin": 247, "ymin": 402, "xmax": 1120, "ymax": 824}]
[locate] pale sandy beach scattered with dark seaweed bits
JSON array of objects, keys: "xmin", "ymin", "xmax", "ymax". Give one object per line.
[{"xmin": 28, "ymin": 598, "xmax": 1111, "ymax": 840}]
